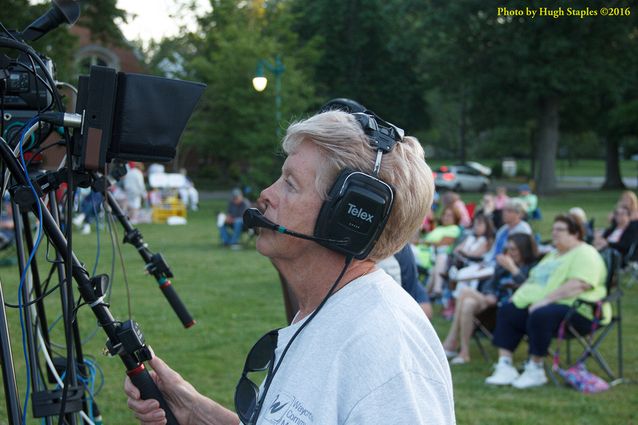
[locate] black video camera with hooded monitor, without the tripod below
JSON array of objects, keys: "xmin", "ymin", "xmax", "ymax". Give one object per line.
[{"xmin": 0, "ymin": 0, "xmax": 205, "ymax": 172}]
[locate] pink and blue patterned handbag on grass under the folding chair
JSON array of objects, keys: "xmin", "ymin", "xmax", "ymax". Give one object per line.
[{"xmin": 552, "ymin": 302, "xmax": 609, "ymax": 394}]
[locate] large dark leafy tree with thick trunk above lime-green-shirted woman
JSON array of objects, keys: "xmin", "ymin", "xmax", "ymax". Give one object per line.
[{"xmin": 425, "ymin": 0, "xmax": 638, "ymax": 194}]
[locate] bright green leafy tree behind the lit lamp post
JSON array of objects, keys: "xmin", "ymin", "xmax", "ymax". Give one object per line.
[{"xmin": 152, "ymin": 0, "xmax": 314, "ymax": 186}]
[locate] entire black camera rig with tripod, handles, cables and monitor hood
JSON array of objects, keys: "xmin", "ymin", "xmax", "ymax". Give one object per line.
[{"xmin": 0, "ymin": 0, "xmax": 205, "ymax": 425}]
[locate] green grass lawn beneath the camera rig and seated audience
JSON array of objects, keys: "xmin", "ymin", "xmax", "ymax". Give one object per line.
[{"xmin": 0, "ymin": 191, "xmax": 638, "ymax": 425}]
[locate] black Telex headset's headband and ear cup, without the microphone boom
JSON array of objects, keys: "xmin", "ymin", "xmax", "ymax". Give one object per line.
[{"xmin": 314, "ymin": 99, "xmax": 404, "ymax": 259}]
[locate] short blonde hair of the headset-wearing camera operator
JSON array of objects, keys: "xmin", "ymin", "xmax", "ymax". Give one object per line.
[{"xmin": 282, "ymin": 111, "xmax": 434, "ymax": 261}]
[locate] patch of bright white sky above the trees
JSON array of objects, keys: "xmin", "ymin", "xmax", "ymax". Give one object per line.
[{"xmin": 117, "ymin": 0, "xmax": 211, "ymax": 45}]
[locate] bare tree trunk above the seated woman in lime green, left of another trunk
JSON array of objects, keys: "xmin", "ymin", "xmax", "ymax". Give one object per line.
[{"xmin": 534, "ymin": 96, "xmax": 560, "ymax": 195}]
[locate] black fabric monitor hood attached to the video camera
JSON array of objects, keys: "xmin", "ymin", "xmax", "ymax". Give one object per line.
[{"xmin": 74, "ymin": 66, "xmax": 206, "ymax": 170}]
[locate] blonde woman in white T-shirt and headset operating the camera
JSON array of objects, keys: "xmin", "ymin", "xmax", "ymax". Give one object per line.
[{"xmin": 125, "ymin": 104, "xmax": 455, "ymax": 425}]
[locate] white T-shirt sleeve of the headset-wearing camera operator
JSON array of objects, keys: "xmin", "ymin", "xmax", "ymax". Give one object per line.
[{"xmin": 344, "ymin": 372, "xmax": 456, "ymax": 425}]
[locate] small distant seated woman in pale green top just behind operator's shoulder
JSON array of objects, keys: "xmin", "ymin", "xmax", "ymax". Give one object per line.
[{"xmin": 416, "ymin": 207, "xmax": 461, "ymax": 295}]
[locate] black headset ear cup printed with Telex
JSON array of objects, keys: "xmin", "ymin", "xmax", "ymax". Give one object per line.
[{"xmin": 314, "ymin": 169, "xmax": 394, "ymax": 259}]
